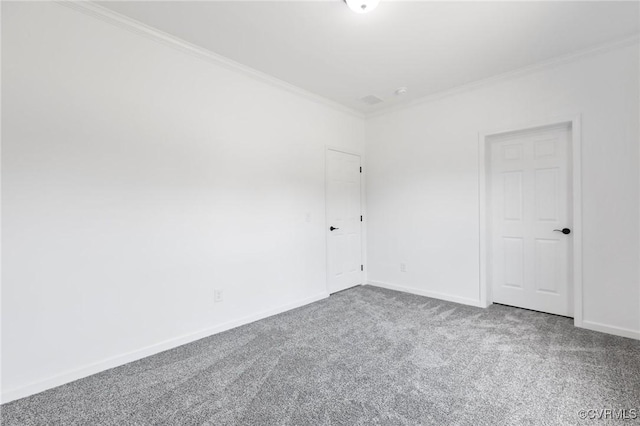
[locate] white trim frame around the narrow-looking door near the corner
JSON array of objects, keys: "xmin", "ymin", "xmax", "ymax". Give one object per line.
[{"xmin": 323, "ymin": 145, "xmax": 367, "ymax": 296}]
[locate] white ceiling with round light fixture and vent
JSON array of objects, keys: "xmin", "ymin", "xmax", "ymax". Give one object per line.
[{"xmin": 99, "ymin": 0, "xmax": 640, "ymax": 113}]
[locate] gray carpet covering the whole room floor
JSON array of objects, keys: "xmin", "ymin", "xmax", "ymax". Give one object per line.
[{"xmin": 1, "ymin": 286, "xmax": 640, "ymax": 426}]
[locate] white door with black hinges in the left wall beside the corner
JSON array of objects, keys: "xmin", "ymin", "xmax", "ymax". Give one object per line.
[{"xmin": 326, "ymin": 150, "xmax": 362, "ymax": 293}]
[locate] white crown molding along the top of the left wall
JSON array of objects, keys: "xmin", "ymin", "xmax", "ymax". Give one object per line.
[{"xmin": 54, "ymin": 0, "xmax": 365, "ymax": 118}]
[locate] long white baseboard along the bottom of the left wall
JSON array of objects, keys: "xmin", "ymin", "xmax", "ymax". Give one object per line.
[{"xmin": 2, "ymin": 292, "xmax": 329, "ymax": 404}]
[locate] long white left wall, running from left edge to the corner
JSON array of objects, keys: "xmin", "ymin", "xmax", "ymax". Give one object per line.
[{"xmin": 2, "ymin": 2, "xmax": 364, "ymax": 401}]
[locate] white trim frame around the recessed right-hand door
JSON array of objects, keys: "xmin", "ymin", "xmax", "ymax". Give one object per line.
[{"xmin": 478, "ymin": 115, "xmax": 582, "ymax": 327}]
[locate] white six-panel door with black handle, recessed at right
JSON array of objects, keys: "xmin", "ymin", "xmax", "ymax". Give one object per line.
[{"xmin": 488, "ymin": 125, "xmax": 573, "ymax": 316}]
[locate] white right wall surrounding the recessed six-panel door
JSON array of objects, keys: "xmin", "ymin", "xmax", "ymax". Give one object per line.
[{"xmin": 366, "ymin": 42, "xmax": 640, "ymax": 338}]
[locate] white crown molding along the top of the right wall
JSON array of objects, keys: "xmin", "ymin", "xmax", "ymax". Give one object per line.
[{"xmin": 365, "ymin": 34, "xmax": 640, "ymax": 119}]
